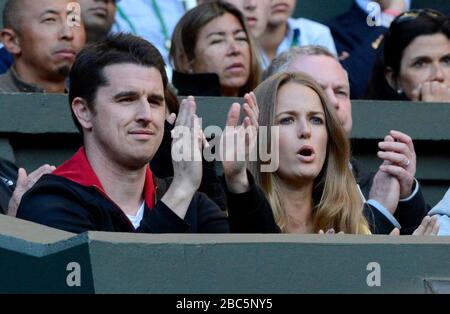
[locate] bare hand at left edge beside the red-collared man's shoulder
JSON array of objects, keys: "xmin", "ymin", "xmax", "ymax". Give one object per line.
[{"xmin": 8, "ymin": 165, "xmax": 56, "ymax": 217}]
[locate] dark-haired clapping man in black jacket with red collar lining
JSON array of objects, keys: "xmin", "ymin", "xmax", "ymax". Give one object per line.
[{"xmin": 18, "ymin": 34, "xmax": 268, "ymax": 233}]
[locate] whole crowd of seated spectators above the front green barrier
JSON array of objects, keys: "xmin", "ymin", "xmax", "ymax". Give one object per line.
[{"xmin": 0, "ymin": 0, "xmax": 450, "ymax": 235}]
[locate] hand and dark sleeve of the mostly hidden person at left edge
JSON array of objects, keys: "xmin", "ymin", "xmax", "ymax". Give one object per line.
[{"xmin": 0, "ymin": 158, "xmax": 55, "ymax": 216}]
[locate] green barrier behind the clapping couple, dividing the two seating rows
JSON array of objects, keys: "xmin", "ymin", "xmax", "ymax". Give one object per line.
[{"xmin": 0, "ymin": 94, "xmax": 450, "ymax": 204}]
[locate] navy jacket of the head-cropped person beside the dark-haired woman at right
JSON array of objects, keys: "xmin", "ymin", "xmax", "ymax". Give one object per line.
[{"xmin": 325, "ymin": 3, "xmax": 387, "ymax": 99}]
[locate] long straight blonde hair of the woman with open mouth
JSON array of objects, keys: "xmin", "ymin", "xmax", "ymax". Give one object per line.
[{"xmin": 249, "ymin": 73, "xmax": 370, "ymax": 234}]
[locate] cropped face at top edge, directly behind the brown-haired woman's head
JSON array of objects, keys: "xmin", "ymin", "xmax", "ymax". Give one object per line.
[{"xmin": 197, "ymin": 0, "xmax": 272, "ymax": 38}]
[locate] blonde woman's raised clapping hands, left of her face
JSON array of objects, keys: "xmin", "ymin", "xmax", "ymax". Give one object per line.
[{"xmin": 220, "ymin": 92, "xmax": 259, "ymax": 193}]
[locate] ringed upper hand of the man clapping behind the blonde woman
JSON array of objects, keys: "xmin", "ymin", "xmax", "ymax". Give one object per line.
[{"xmin": 378, "ymin": 131, "xmax": 416, "ymax": 198}]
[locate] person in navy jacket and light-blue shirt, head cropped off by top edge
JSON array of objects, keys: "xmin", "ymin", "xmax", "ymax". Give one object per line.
[{"xmin": 326, "ymin": 0, "xmax": 410, "ymax": 99}]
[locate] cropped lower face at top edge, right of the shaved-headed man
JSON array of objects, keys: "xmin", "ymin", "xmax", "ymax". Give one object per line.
[{"xmin": 78, "ymin": 0, "xmax": 117, "ymax": 44}]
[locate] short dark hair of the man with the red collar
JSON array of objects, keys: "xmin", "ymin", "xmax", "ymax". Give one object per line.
[{"xmin": 69, "ymin": 33, "xmax": 168, "ymax": 132}]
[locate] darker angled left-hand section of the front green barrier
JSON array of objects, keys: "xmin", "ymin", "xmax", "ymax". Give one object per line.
[{"xmin": 0, "ymin": 215, "xmax": 94, "ymax": 293}]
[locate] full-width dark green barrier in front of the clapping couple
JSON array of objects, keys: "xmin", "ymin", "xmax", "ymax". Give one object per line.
[{"xmin": 0, "ymin": 215, "xmax": 450, "ymax": 294}]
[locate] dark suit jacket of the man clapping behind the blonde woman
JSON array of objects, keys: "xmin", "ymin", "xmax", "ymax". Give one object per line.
[{"xmin": 351, "ymin": 159, "xmax": 430, "ymax": 234}]
